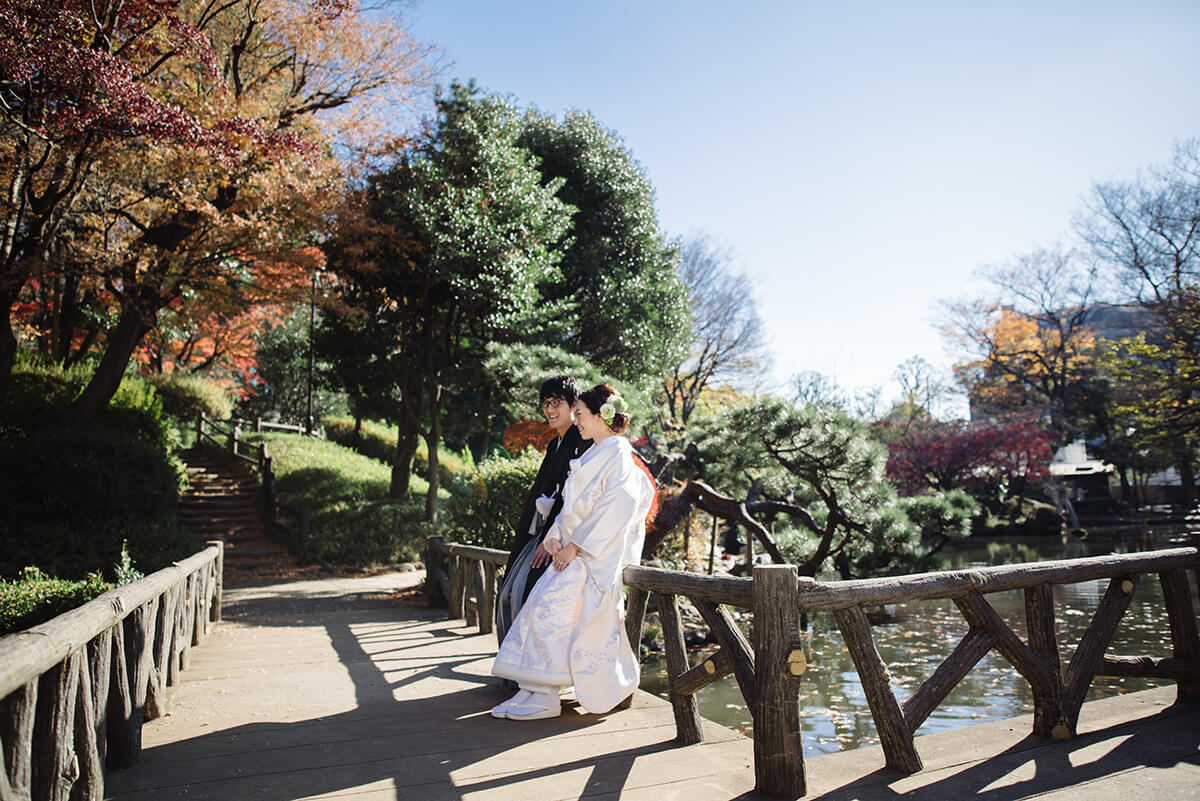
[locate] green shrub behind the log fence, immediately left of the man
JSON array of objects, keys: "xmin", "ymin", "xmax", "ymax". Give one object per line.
[{"xmin": 444, "ymin": 447, "xmax": 542, "ymax": 548}]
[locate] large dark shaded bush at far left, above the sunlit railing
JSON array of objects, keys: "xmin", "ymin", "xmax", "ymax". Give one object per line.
[{"xmin": 0, "ymin": 429, "xmax": 196, "ymax": 580}]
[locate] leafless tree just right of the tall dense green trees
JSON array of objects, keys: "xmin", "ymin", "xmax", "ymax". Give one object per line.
[{"xmin": 659, "ymin": 237, "xmax": 770, "ymax": 426}]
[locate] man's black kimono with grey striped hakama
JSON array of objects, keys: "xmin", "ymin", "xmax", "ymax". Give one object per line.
[{"xmin": 496, "ymin": 426, "xmax": 592, "ymax": 640}]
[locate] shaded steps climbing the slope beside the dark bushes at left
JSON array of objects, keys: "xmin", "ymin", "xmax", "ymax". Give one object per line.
[{"xmin": 179, "ymin": 448, "xmax": 298, "ymax": 586}]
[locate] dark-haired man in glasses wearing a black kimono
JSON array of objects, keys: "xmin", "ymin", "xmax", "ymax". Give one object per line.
[{"xmin": 496, "ymin": 375, "xmax": 592, "ymax": 642}]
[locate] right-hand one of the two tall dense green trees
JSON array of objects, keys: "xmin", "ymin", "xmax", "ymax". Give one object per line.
[{"xmin": 517, "ymin": 110, "xmax": 689, "ymax": 384}]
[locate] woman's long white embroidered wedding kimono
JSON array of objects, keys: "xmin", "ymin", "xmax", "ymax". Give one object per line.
[{"xmin": 492, "ymin": 436, "xmax": 654, "ymax": 713}]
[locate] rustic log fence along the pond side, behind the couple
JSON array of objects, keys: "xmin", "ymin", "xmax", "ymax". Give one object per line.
[{"xmin": 426, "ymin": 540, "xmax": 1200, "ymax": 797}]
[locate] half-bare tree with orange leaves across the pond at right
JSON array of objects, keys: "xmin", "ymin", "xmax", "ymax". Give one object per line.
[{"xmin": 942, "ymin": 249, "xmax": 1096, "ymax": 435}]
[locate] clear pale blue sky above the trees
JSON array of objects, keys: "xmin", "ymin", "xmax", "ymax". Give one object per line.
[{"xmin": 406, "ymin": 0, "xmax": 1200, "ymax": 412}]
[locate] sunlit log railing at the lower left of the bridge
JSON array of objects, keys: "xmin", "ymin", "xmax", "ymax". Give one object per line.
[{"xmin": 0, "ymin": 542, "xmax": 224, "ymax": 801}]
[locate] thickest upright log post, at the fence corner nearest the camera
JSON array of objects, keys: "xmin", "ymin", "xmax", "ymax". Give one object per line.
[{"xmin": 750, "ymin": 565, "xmax": 808, "ymax": 797}]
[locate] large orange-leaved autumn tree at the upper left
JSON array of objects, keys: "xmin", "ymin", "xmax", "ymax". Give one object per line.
[{"xmin": 0, "ymin": 0, "xmax": 419, "ymax": 421}]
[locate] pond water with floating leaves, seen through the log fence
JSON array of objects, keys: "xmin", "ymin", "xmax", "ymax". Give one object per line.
[{"xmin": 642, "ymin": 526, "xmax": 1196, "ymax": 754}]
